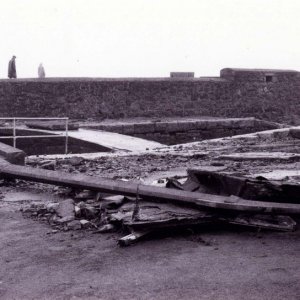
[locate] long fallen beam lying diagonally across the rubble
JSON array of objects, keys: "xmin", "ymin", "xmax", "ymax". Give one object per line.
[{"xmin": 0, "ymin": 163, "xmax": 300, "ymax": 214}]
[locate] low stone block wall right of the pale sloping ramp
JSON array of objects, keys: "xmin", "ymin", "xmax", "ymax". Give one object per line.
[{"xmin": 85, "ymin": 118, "xmax": 278, "ymax": 145}]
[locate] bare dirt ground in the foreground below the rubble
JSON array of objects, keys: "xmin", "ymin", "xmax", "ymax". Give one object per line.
[{"xmin": 0, "ymin": 193, "xmax": 300, "ymax": 299}]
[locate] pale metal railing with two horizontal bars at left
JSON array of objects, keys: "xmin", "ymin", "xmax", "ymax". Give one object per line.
[{"xmin": 0, "ymin": 118, "xmax": 69, "ymax": 154}]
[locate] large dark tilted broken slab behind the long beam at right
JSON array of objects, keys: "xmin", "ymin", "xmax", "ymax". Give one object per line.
[{"xmin": 172, "ymin": 168, "xmax": 300, "ymax": 204}]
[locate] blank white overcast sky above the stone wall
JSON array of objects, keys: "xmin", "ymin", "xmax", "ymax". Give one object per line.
[{"xmin": 0, "ymin": 0, "xmax": 300, "ymax": 78}]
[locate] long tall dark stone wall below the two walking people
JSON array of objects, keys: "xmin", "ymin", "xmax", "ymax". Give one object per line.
[{"xmin": 0, "ymin": 69, "xmax": 300, "ymax": 123}]
